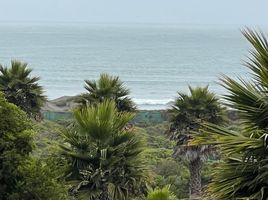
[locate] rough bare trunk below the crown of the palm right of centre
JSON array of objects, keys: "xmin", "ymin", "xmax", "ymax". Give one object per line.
[{"xmin": 189, "ymin": 158, "xmax": 203, "ymax": 200}]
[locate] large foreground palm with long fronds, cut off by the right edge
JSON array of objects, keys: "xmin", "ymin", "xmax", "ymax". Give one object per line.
[{"xmin": 192, "ymin": 29, "xmax": 268, "ymax": 200}]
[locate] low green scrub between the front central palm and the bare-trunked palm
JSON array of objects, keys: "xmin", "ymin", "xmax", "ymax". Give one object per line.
[{"xmin": 137, "ymin": 122, "xmax": 189, "ymax": 199}]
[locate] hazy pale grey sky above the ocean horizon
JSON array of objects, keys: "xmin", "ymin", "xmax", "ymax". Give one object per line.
[{"xmin": 0, "ymin": 0, "xmax": 268, "ymax": 25}]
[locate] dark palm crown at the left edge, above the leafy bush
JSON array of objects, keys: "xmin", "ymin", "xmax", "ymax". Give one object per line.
[{"xmin": 0, "ymin": 60, "xmax": 46, "ymax": 117}]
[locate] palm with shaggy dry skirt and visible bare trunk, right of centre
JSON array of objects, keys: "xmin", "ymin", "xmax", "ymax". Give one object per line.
[{"xmin": 169, "ymin": 87, "xmax": 223, "ymax": 199}]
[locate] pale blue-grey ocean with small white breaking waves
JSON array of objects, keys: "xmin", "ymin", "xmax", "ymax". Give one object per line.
[{"xmin": 0, "ymin": 23, "xmax": 254, "ymax": 109}]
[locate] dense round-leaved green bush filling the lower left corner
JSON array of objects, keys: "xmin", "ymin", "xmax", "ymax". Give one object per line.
[{"xmin": 0, "ymin": 93, "xmax": 67, "ymax": 200}]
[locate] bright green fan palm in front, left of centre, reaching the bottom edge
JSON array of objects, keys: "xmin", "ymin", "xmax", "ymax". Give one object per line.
[{"xmin": 60, "ymin": 100, "xmax": 146, "ymax": 200}]
